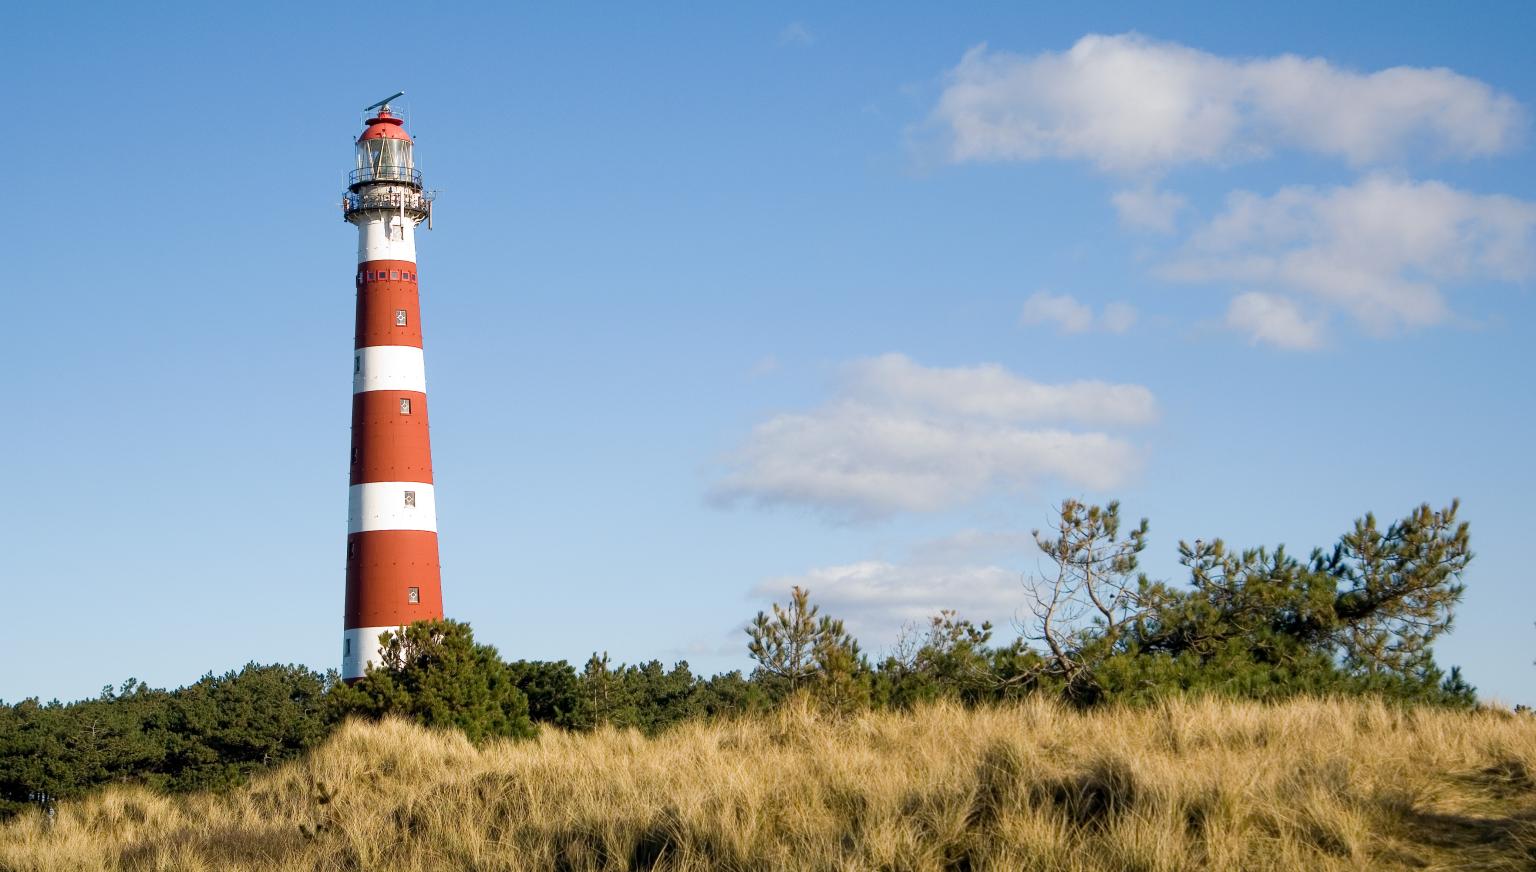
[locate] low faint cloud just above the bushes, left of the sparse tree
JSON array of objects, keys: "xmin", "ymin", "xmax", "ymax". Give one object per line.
[{"xmin": 753, "ymin": 560, "xmax": 1025, "ymax": 646}]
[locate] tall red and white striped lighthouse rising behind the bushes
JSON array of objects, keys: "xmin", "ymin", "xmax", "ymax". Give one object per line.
[{"xmin": 341, "ymin": 94, "xmax": 442, "ymax": 682}]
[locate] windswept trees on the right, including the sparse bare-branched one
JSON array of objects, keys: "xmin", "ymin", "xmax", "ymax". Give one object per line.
[{"xmin": 1018, "ymin": 500, "xmax": 1475, "ymax": 705}]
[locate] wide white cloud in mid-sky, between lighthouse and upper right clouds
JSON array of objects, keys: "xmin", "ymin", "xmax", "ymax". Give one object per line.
[{"xmin": 710, "ymin": 355, "xmax": 1157, "ymax": 520}]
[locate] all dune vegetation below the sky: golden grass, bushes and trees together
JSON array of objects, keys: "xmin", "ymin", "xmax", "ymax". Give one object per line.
[{"xmin": 0, "ymin": 500, "xmax": 1505, "ymax": 872}]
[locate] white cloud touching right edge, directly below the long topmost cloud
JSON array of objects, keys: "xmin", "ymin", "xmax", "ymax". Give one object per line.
[{"xmin": 1160, "ymin": 175, "xmax": 1536, "ymax": 333}]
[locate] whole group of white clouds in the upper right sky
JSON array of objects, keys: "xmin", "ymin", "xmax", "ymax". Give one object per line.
[{"xmin": 929, "ymin": 34, "xmax": 1536, "ymax": 350}]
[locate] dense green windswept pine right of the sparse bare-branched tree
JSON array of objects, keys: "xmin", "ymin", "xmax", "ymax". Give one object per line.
[{"xmin": 1126, "ymin": 502, "xmax": 1476, "ymax": 705}]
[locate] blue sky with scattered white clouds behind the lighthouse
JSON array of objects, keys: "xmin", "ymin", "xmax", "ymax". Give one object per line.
[{"xmin": 9, "ymin": 3, "xmax": 1536, "ymax": 703}]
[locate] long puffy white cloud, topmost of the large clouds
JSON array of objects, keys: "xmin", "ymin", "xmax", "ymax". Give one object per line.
[{"xmin": 932, "ymin": 34, "xmax": 1525, "ymax": 170}]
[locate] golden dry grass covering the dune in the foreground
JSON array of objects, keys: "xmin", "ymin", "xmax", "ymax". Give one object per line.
[{"xmin": 0, "ymin": 700, "xmax": 1536, "ymax": 872}]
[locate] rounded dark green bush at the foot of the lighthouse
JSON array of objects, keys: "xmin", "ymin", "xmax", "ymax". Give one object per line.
[{"xmin": 330, "ymin": 620, "xmax": 535, "ymax": 742}]
